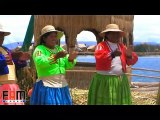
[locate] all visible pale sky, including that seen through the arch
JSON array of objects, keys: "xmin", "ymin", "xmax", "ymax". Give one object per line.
[{"xmin": 0, "ymin": 15, "xmax": 160, "ymax": 44}]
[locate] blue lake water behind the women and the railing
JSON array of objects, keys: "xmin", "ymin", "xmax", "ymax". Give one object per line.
[{"xmin": 77, "ymin": 55, "xmax": 160, "ymax": 82}]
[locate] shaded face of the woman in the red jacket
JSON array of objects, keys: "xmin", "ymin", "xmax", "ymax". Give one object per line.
[{"xmin": 107, "ymin": 32, "xmax": 122, "ymax": 43}]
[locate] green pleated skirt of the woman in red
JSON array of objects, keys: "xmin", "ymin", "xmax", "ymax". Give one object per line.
[{"xmin": 88, "ymin": 73, "xmax": 132, "ymax": 105}]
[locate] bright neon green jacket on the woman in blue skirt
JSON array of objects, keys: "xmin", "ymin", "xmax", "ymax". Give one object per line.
[{"xmin": 33, "ymin": 45, "xmax": 76, "ymax": 78}]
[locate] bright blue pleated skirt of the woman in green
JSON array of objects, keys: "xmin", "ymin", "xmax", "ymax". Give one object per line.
[{"xmin": 30, "ymin": 80, "xmax": 72, "ymax": 105}]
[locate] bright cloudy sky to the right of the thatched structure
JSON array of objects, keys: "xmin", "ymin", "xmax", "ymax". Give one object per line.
[{"xmin": 133, "ymin": 15, "xmax": 160, "ymax": 43}]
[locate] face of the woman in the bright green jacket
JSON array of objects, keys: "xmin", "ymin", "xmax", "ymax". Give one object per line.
[{"xmin": 44, "ymin": 32, "xmax": 57, "ymax": 48}]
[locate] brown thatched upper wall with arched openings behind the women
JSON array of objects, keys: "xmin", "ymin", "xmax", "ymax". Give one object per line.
[{"xmin": 34, "ymin": 15, "xmax": 134, "ymax": 51}]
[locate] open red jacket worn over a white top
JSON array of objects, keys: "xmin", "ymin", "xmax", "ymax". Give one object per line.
[{"xmin": 95, "ymin": 41, "xmax": 138, "ymax": 72}]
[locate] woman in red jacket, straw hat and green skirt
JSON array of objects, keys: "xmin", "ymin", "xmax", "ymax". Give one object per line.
[{"xmin": 88, "ymin": 24, "xmax": 138, "ymax": 105}]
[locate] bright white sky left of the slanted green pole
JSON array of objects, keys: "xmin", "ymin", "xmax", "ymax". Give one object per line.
[{"xmin": 0, "ymin": 15, "xmax": 31, "ymax": 44}]
